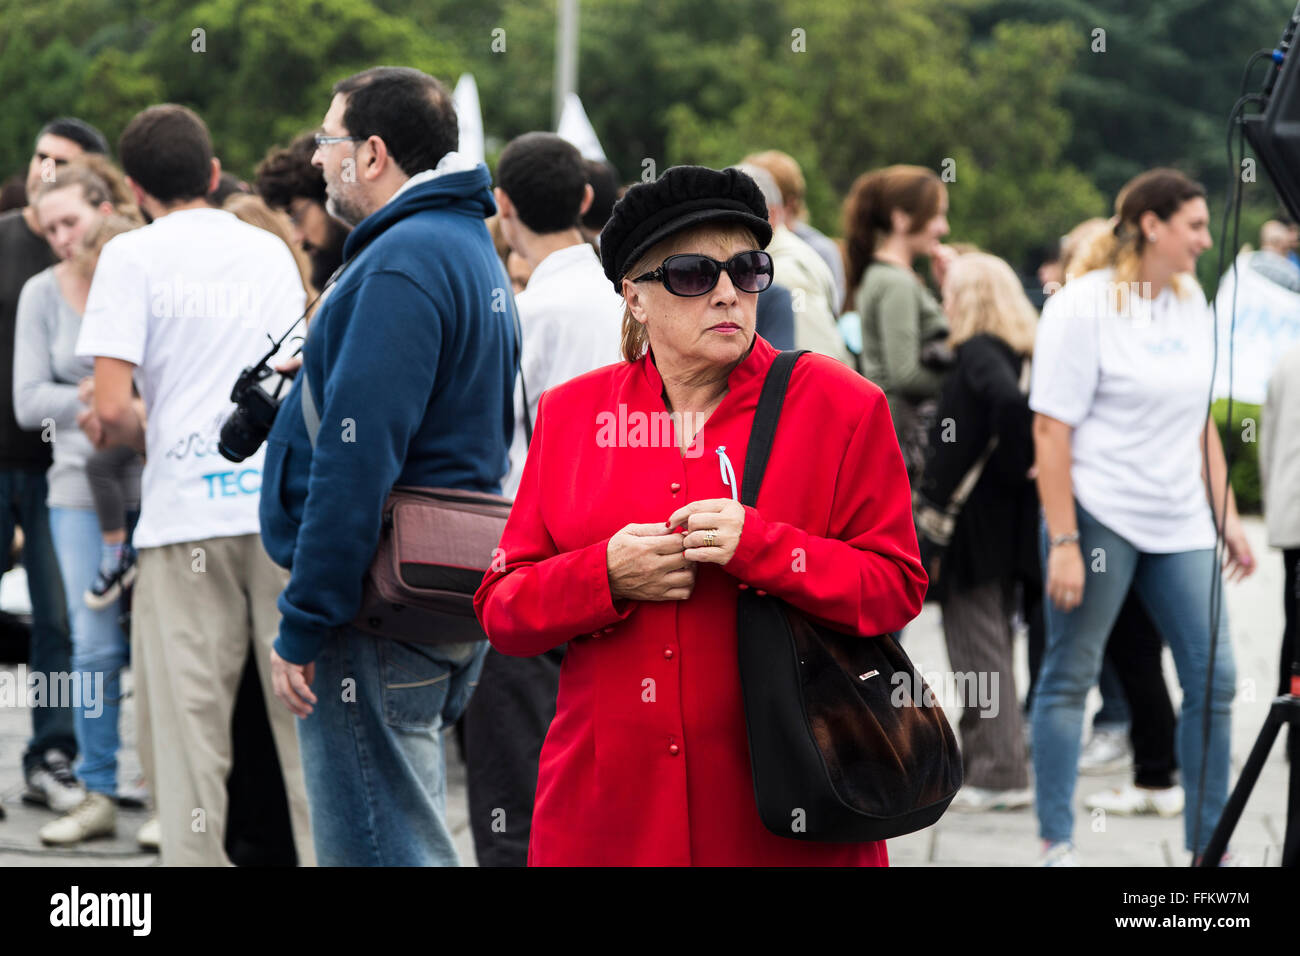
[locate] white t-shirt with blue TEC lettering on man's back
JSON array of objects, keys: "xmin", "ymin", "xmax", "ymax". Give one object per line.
[{"xmin": 77, "ymin": 209, "xmax": 306, "ymax": 548}]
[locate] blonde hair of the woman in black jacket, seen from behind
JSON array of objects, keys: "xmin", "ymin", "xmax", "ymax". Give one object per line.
[{"xmin": 944, "ymin": 252, "xmax": 1039, "ymax": 355}]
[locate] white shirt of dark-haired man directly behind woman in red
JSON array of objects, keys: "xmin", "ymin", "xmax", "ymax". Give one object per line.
[{"xmin": 502, "ymin": 242, "xmax": 624, "ymax": 497}]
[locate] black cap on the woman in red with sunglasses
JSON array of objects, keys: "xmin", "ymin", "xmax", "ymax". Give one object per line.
[{"xmin": 601, "ymin": 166, "xmax": 772, "ymax": 293}]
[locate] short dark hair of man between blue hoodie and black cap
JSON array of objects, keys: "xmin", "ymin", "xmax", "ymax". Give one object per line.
[{"xmin": 497, "ymin": 133, "xmax": 586, "ymax": 233}]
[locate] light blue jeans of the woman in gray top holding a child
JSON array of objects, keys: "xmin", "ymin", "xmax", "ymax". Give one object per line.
[{"xmin": 49, "ymin": 507, "xmax": 135, "ymax": 797}]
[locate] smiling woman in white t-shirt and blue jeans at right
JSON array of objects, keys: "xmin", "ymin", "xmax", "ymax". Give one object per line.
[{"xmin": 1030, "ymin": 169, "xmax": 1255, "ymax": 866}]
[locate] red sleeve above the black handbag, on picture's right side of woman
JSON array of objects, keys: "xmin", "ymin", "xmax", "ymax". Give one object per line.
[{"xmin": 724, "ymin": 390, "xmax": 930, "ymax": 635}]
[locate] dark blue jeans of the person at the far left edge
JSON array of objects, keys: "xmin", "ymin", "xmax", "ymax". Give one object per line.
[{"xmin": 0, "ymin": 468, "xmax": 77, "ymax": 773}]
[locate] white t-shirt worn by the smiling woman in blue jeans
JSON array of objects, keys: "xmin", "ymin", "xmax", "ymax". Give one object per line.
[{"xmin": 1030, "ymin": 269, "xmax": 1214, "ymax": 557}]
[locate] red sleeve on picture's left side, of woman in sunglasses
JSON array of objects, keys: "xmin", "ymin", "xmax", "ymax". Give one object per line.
[{"xmin": 475, "ymin": 393, "xmax": 634, "ymax": 657}]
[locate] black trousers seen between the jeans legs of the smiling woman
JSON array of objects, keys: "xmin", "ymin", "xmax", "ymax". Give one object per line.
[{"xmin": 1106, "ymin": 592, "xmax": 1178, "ymax": 787}]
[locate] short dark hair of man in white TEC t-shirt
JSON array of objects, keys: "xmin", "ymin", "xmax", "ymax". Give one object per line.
[{"xmin": 117, "ymin": 103, "xmax": 212, "ymax": 203}]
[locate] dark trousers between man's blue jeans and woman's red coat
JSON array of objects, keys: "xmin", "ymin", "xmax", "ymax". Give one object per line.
[{"xmin": 463, "ymin": 646, "xmax": 564, "ymax": 866}]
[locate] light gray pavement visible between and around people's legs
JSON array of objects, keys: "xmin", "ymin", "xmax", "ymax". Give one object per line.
[{"xmin": 0, "ymin": 519, "xmax": 1287, "ymax": 868}]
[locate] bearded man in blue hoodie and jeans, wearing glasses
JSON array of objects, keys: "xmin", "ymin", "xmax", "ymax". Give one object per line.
[{"xmin": 261, "ymin": 66, "xmax": 516, "ymax": 866}]
